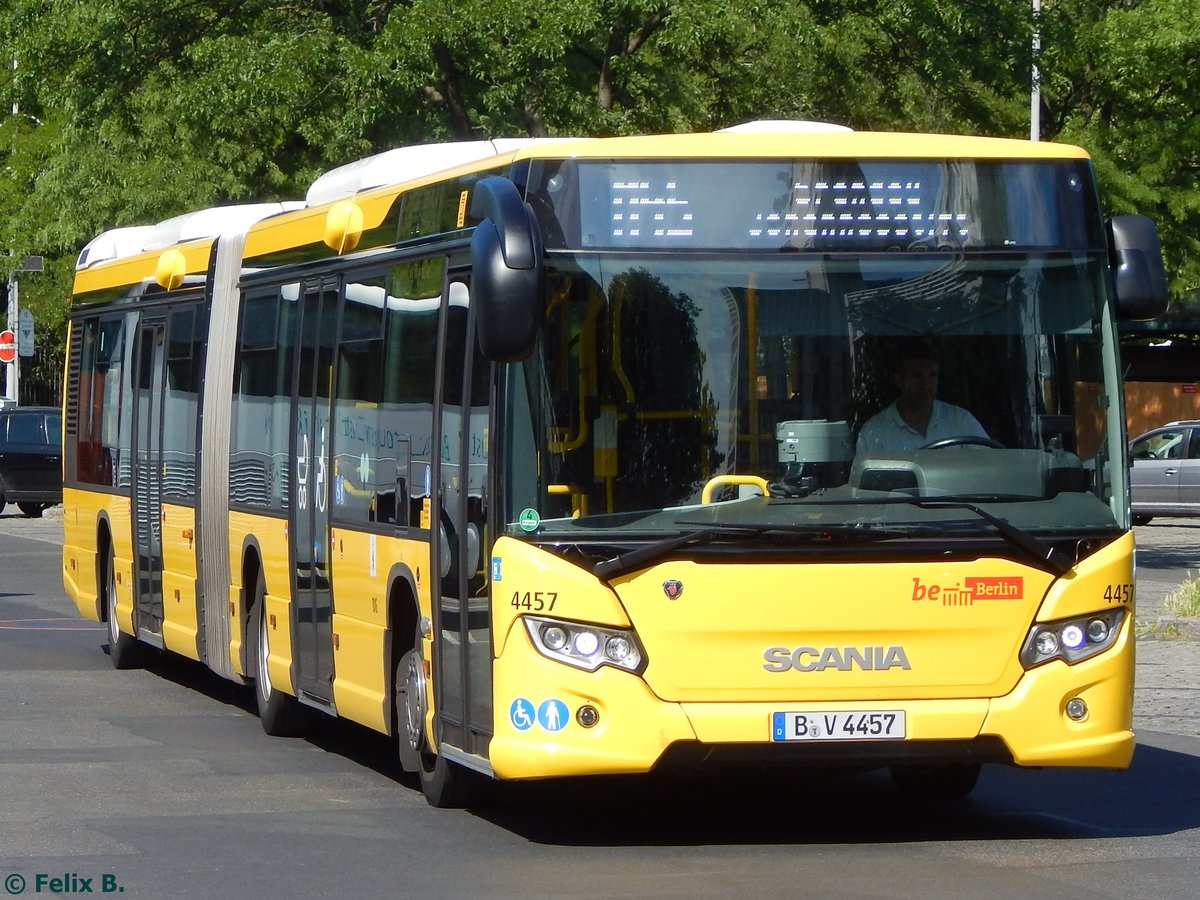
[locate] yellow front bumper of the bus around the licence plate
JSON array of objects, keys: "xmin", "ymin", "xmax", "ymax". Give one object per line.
[{"xmin": 488, "ymin": 626, "xmax": 1134, "ymax": 779}]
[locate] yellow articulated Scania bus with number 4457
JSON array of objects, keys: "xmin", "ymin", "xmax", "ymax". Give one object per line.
[{"xmin": 62, "ymin": 122, "xmax": 1165, "ymax": 805}]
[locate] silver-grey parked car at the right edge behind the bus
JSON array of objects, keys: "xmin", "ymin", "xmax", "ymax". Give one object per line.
[{"xmin": 1129, "ymin": 419, "xmax": 1200, "ymax": 524}]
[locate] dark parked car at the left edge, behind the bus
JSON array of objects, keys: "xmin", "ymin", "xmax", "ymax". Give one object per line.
[{"xmin": 0, "ymin": 407, "xmax": 62, "ymax": 518}]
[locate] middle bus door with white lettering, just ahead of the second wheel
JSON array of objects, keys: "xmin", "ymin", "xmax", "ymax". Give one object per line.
[{"xmin": 288, "ymin": 280, "xmax": 340, "ymax": 703}]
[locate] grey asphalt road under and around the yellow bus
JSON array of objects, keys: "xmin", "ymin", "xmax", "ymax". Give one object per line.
[{"xmin": 0, "ymin": 512, "xmax": 1200, "ymax": 898}]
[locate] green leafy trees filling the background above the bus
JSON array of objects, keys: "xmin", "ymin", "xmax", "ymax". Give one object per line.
[{"xmin": 0, "ymin": 0, "xmax": 1200, "ymax": 388}]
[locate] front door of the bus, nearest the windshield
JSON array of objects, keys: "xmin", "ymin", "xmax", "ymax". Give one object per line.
[{"xmin": 430, "ymin": 276, "xmax": 493, "ymax": 757}]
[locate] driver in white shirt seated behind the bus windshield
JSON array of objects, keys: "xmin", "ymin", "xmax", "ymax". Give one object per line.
[{"xmin": 856, "ymin": 344, "xmax": 989, "ymax": 454}]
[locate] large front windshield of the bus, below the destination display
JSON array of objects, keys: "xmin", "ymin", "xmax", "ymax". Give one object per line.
[{"xmin": 503, "ymin": 250, "xmax": 1122, "ymax": 541}]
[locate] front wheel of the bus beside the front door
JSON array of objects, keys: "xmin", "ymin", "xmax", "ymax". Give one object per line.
[{"xmin": 395, "ymin": 629, "xmax": 481, "ymax": 809}]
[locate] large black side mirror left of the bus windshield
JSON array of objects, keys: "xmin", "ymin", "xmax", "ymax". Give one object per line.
[{"xmin": 470, "ymin": 175, "xmax": 545, "ymax": 362}]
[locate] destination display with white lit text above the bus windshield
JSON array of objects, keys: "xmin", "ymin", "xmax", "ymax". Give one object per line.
[{"xmin": 534, "ymin": 160, "xmax": 1104, "ymax": 252}]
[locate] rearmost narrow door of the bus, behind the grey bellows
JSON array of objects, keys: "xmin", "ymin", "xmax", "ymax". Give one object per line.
[{"xmin": 132, "ymin": 316, "xmax": 167, "ymax": 635}]
